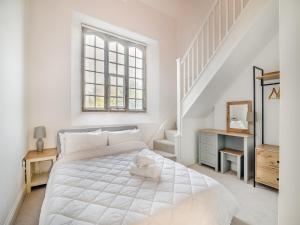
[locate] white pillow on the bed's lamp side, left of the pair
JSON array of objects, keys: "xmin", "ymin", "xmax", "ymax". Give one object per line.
[{"xmin": 62, "ymin": 132, "xmax": 108, "ymax": 155}]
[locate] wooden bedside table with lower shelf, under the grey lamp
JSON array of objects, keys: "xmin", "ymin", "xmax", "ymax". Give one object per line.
[{"xmin": 25, "ymin": 148, "xmax": 57, "ymax": 193}]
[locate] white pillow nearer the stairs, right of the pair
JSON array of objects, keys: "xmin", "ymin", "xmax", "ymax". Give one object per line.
[{"xmin": 108, "ymin": 129, "xmax": 142, "ymax": 145}]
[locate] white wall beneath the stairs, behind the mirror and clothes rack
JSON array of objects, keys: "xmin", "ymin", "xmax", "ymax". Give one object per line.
[{"xmin": 211, "ymin": 35, "xmax": 279, "ymax": 145}]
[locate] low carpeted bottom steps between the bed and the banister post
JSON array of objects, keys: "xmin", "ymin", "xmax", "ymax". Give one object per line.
[{"xmin": 153, "ymin": 130, "xmax": 177, "ymax": 161}]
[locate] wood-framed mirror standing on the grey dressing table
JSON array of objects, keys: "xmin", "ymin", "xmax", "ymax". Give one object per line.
[{"xmin": 227, "ymin": 101, "xmax": 252, "ymax": 134}]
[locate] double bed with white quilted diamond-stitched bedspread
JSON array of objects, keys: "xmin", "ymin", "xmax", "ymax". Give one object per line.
[{"xmin": 39, "ymin": 127, "xmax": 238, "ymax": 225}]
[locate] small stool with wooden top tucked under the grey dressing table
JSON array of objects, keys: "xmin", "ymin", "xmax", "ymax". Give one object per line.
[{"xmin": 220, "ymin": 149, "xmax": 244, "ymax": 179}]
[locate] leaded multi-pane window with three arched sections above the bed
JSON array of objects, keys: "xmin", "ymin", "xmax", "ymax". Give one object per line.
[{"xmin": 82, "ymin": 26, "xmax": 146, "ymax": 112}]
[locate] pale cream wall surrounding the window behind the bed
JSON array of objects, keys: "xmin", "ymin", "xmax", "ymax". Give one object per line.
[{"xmin": 28, "ymin": 0, "xmax": 176, "ymax": 148}]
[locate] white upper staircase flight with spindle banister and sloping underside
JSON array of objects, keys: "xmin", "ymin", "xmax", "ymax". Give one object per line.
[{"xmin": 175, "ymin": 0, "xmax": 278, "ymax": 164}]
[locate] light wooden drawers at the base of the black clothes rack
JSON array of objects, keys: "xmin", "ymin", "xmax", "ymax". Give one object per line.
[{"xmin": 255, "ymin": 145, "xmax": 279, "ymax": 189}]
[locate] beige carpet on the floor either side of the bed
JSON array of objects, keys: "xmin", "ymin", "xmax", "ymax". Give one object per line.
[{"xmin": 15, "ymin": 165, "xmax": 278, "ymax": 225}]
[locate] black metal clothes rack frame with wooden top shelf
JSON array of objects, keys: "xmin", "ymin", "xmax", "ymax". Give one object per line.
[{"xmin": 253, "ymin": 66, "xmax": 280, "ymax": 187}]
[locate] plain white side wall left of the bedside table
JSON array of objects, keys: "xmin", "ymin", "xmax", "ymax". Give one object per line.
[{"xmin": 0, "ymin": 0, "xmax": 26, "ymax": 224}]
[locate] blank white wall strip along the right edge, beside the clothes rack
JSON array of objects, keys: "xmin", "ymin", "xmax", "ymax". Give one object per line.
[{"xmin": 278, "ymin": 0, "xmax": 300, "ymax": 225}]
